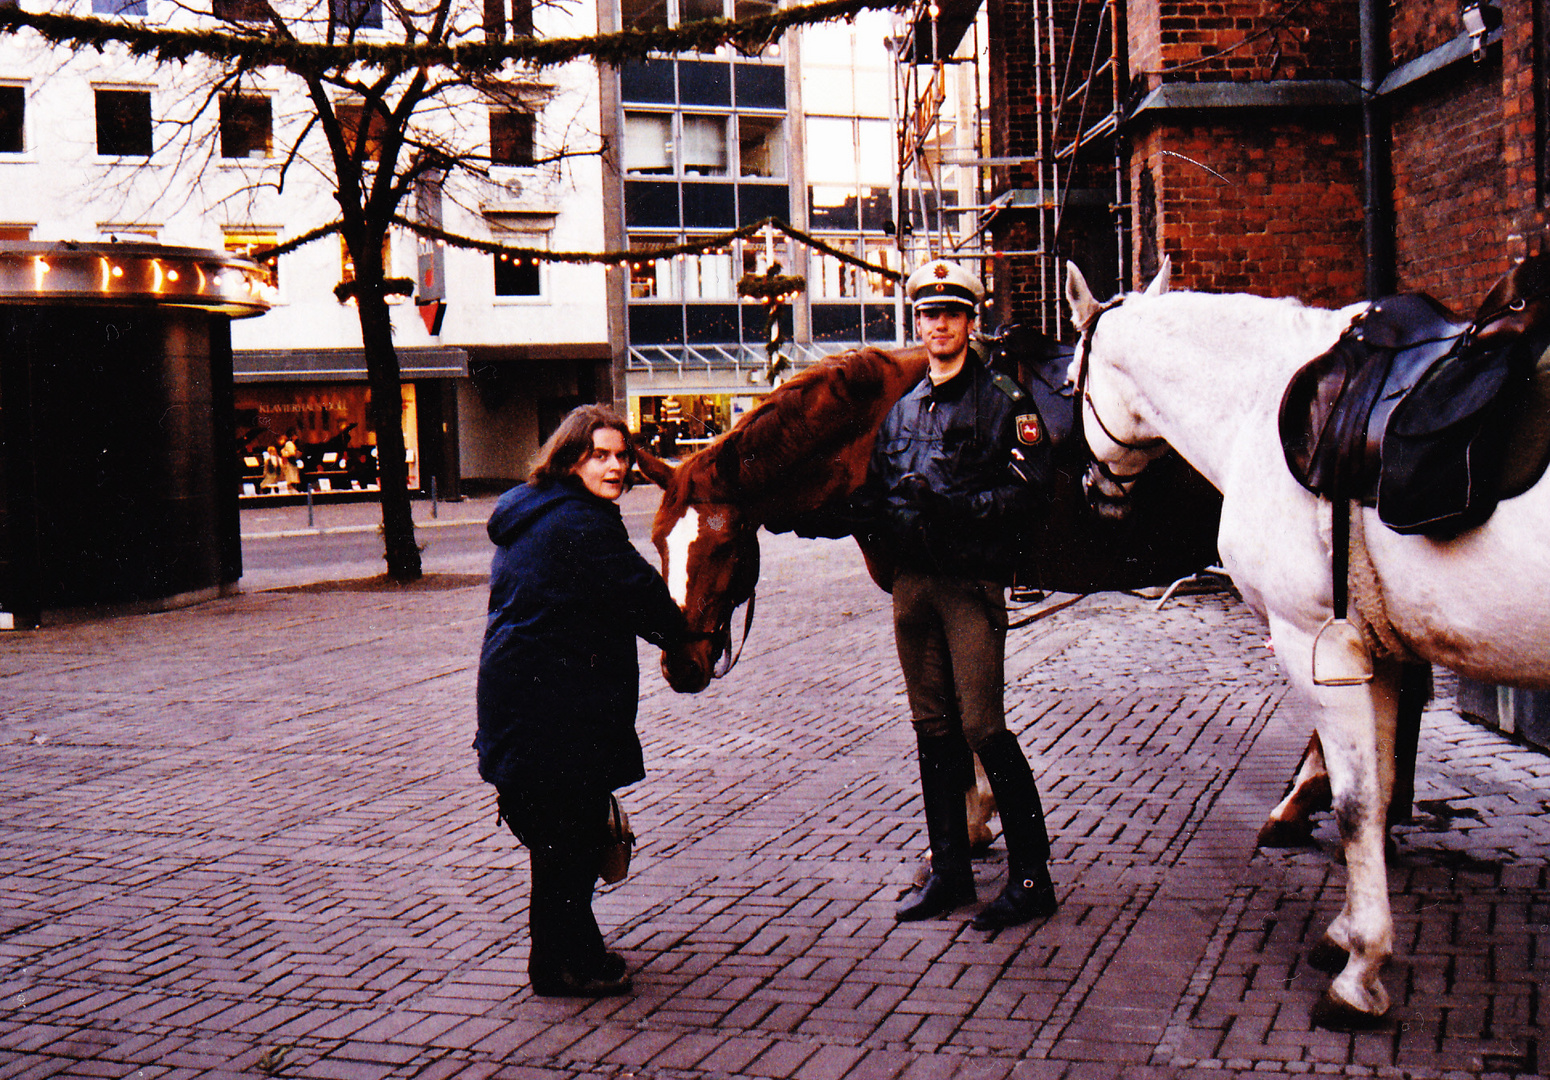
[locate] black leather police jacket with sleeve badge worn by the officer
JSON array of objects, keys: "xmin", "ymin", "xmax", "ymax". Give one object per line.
[{"xmin": 859, "ymin": 353, "xmax": 1051, "ymax": 583}]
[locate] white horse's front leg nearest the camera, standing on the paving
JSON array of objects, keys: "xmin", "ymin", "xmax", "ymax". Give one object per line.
[{"xmin": 1273, "ymin": 623, "xmax": 1400, "ymax": 1018}]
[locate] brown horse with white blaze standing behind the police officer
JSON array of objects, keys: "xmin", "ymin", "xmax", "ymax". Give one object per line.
[{"xmin": 639, "ymin": 341, "xmax": 1221, "ymax": 694}]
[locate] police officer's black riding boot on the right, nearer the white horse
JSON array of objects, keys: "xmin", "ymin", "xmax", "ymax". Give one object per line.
[{"xmin": 970, "ymin": 731, "xmax": 1059, "ymax": 930}]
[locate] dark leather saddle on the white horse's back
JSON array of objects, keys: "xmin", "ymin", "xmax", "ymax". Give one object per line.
[{"xmin": 1279, "ymin": 256, "xmax": 1550, "ymax": 536}]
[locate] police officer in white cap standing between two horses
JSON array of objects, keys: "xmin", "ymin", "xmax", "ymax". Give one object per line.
[{"xmin": 863, "ymin": 259, "xmax": 1057, "ymax": 930}]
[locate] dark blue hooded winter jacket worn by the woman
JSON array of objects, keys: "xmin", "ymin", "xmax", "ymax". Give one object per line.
[{"xmin": 474, "ymin": 480, "xmax": 685, "ymax": 790}]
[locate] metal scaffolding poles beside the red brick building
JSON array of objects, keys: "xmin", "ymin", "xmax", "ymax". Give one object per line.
[{"xmin": 894, "ymin": 0, "xmax": 1130, "ymax": 336}]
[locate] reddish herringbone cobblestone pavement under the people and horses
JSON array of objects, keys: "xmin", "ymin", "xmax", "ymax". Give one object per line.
[{"xmin": 0, "ymin": 493, "xmax": 1550, "ymax": 1080}]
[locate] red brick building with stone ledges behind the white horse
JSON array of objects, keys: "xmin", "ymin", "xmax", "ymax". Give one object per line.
[{"xmin": 989, "ymin": 0, "xmax": 1550, "ymax": 321}]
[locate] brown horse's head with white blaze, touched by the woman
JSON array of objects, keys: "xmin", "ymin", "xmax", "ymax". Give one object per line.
[{"xmin": 637, "ymin": 451, "xmax": 760, "ymax": 694}]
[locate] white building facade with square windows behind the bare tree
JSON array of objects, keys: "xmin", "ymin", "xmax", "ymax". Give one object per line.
[{"xmin": 0, "ymin": 0, "xmax": 617, "ymax": 494}]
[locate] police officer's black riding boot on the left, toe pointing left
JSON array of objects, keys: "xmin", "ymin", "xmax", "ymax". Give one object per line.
[{"xmin": 893, "ymin": 728, "xmax": 975, "ymax": 922}]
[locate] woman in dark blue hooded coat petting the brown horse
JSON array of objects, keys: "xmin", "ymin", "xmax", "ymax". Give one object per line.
[{"xmin": 474, "ymin": 404, "xmax": 685, "ymax": 996}]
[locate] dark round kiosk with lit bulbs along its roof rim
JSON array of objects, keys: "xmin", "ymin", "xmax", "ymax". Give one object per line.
[{"xmin": 0, "ymin": 242, "xmax": 268, "ymax": 629}]
